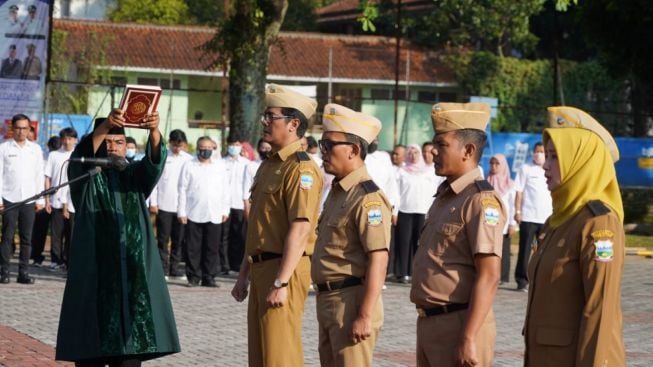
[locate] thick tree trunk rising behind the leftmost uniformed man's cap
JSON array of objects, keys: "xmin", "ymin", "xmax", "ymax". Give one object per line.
[{"xmin": 205, "ymin": 0, "xmax": 296, "ymax": 141}]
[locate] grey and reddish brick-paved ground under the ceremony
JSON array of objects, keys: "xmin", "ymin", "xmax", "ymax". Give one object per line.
[{"xmin": 0, "ymin": 256, "xmax": 653, "ymax": 367}]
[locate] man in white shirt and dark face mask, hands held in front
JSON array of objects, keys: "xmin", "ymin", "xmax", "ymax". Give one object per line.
[{"xmin": 177, "ymin": 136, "xmax": 234, "ymax": 287}]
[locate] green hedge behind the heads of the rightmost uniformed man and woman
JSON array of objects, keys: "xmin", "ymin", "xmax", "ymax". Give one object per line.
[{"xmin": 445, "ymin": 52, "xmax": 625, "ymax": 134}]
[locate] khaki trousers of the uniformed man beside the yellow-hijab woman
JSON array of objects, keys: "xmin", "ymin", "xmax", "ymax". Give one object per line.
[{"xmin": 417, "ymin": 310, "xmax": 497, "ymax": 367}]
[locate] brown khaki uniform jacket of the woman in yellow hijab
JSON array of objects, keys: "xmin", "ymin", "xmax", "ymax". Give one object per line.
[{"xmin": 524, "ymin": 204, "xmax": 626, "ymax": 367}]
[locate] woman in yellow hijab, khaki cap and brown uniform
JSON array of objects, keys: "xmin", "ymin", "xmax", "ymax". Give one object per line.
[{"xmin": 524, "ymin": 107, "xmax": 626, "ymax": 367}]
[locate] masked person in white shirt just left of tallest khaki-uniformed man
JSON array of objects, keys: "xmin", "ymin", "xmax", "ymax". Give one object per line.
[{"xmin": 220, "ymin": 134, "xmax": 250, "ymax": 275}]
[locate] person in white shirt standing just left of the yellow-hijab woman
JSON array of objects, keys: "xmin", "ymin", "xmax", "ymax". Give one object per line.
[{"xmin": 515, "ymin": 142, "xmax": 553, "ymax": 292}]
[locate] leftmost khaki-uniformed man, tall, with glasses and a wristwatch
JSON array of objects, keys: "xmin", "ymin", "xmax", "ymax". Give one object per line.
[{"xmin": 231, "ymin": 85, "xmax": 322, "ymax": 367}]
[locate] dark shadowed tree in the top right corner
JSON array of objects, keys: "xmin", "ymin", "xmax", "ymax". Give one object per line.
[{"xmin": 581, "ymin": 0, "xmax": 653, "ymax": 136}]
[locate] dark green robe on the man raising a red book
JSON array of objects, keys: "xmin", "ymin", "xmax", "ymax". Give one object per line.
[{"xmin": 56, "ymin": 134, "xmax": 180, "ymax": 361}]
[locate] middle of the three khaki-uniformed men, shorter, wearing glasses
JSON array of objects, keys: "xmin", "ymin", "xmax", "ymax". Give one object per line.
[{"xmin": 311, "ymin": 104, "xmax": 392, "ymax": 367}]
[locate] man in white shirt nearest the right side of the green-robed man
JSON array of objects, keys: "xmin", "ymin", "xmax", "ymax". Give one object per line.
[{"xmin": 150, "ymin": 129, "xmax": 193, "ymax": 278}]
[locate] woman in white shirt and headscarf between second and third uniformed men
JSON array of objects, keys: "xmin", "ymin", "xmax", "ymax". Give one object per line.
[{"xmin": 394, "ymin": 144, "xmax": 438, "ymax": 283}]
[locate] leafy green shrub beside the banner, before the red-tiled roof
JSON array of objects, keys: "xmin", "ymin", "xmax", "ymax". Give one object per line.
[{"xmin": 48, "ymin": 29, "xmax": 112, "ymax": 114}]
